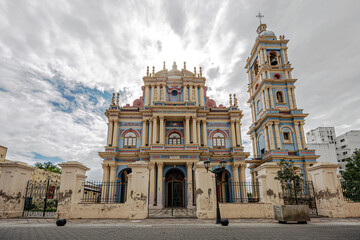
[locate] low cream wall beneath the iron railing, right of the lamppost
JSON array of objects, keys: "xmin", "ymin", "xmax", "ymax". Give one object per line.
[{"xmin": 219, "ymin": 203, "xmax": 274, "ymax": 218}]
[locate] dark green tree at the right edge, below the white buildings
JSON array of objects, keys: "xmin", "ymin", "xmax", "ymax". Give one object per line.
[{"xmin": 341, "ymin": 149, "xmax": 360, "ymax": 202}]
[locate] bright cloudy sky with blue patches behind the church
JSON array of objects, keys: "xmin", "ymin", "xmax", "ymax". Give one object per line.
[{"xmin": 0, "ymin": 0, "xmax": 360, "ymax": 179}]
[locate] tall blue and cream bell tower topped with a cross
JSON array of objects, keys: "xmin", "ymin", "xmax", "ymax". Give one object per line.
[{"xmin": 245, "ymin": 13, "xmax": 318, "ymax": 181}]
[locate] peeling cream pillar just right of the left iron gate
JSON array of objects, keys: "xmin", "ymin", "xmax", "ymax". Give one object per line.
[{"xmin": 56, "ymin": 161, "xmax": 89, "ymax": 218}]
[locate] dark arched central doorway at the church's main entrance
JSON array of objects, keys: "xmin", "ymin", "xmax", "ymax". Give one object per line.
[{"xmin": 165, "ymin": 168, "xmax": 185, "ymax": 207}]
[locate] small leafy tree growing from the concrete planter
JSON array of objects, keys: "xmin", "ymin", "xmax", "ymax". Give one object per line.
[{"xmin": 275, "ymin": 159, "xmax": 302, "ymax": 204}]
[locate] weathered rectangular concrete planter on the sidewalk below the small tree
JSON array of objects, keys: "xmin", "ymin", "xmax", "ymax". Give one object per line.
[{"xmin": 274, "ymin": 205, "xmax": 311, "ymax": 223}]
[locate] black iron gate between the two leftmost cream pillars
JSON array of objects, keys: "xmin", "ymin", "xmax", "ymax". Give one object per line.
[{"xmin": 23, "ymin": 179, "xmax": 60, "ymax": 217}]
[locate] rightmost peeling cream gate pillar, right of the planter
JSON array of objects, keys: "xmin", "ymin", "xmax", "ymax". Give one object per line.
[{"xmin": 308, "ymin": 163, "xmax": 347, "ymax": 217}]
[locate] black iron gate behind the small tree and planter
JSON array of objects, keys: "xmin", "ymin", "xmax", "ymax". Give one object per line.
[{"xmin": 282, "ymin": 181, "xmax": 318, "ymax": 216}]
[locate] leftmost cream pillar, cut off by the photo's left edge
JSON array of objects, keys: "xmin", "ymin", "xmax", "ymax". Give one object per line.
[{"xmin": 0, "ymin": 161, "xmax": 35, "ymax": 218}]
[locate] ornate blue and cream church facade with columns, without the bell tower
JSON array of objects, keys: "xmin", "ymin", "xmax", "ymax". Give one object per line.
[{"xmin": 99, "ymin": 62, "xmax": 250, "ymax": 208}]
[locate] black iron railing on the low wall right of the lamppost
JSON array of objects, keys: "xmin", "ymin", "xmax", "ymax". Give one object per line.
[{"xmin": 217, "ymin": 181, "xmax": 260, "ymax": 203}]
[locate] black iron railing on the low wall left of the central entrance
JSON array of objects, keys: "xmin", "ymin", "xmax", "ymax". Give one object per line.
[{"xmin": 81, "ymin": 181, "xmax": 127, "ymax": 203}]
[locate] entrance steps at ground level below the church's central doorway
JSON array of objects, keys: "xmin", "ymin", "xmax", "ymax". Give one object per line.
[{"xmin": 149, "ymin": 208, "xmax": 196, "ymax": 218}]
